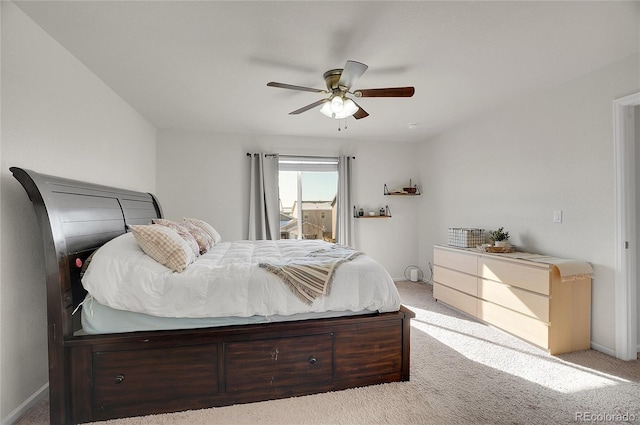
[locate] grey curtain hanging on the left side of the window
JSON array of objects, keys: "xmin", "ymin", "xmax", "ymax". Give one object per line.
[{"xmin": 248, "ymin": 153, "xmax": 280, "ymax": 241}]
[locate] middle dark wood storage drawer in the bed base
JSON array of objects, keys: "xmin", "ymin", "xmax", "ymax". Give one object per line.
[{"xmin": 224, "ymin": 334, "xmax": 333, "ymax": 392}]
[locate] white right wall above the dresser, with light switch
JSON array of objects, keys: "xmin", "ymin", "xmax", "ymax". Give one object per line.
[{"xmin": 419, "ymin": 55, "xmax": 640, "ymax": 354}]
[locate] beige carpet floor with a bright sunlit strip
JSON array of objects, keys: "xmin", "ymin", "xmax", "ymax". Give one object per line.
[{"xmin": 13, "ymin": 282, "xmax": 640, "ymax": 425}]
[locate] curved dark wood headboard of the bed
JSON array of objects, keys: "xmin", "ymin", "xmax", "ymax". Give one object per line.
[{"xmin": 10, "ymin": 167, "xmax": 162, "ymax": 337}]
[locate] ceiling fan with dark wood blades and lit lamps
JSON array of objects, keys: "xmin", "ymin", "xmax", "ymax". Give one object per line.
[{"xmin": 267, "ymin": 60, "xmax": 415, "ymax": 120}]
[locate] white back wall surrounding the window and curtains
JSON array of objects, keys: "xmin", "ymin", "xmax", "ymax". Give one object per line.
[{"xmin": 157, "ymin": 129, "xmax": 420, "ymax": 278}]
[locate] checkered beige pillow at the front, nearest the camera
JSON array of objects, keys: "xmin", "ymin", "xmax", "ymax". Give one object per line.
[{"xmin": 129, "ymin": 224, "xmax": 196, "ymax": 272}]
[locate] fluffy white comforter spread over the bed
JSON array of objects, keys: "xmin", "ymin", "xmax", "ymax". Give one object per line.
[{"xmin": 82, "ymin": 233, "xmax": 400, "ymax": 317}]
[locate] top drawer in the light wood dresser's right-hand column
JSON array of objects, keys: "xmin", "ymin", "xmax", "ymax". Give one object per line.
[{"xmin": 478, "ymin": 258, "xmax": 550, "ymax": 295}]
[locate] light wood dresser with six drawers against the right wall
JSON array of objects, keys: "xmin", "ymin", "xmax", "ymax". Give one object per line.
[{"xmin": 433, "ymin": 246, "xmax": 591, "ymax": 354}]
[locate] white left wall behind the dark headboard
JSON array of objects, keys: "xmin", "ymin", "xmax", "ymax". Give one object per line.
[{"xmin": 0, "ymin": 1, "xmax": 156, "ymax": 423}]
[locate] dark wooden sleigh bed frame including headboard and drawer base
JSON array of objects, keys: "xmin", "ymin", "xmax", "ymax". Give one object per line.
[{"xmin": 10, "ymin": 167, "xmax": 414, "ymax": 424}]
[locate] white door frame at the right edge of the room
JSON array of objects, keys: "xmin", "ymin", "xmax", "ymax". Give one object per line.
[{"xmin": 613, "ymin": 92, "xmax": 640, "ymax": 360}]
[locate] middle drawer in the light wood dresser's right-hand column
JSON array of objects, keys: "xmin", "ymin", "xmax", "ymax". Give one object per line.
[{"xmin": 478, "ymin": 279, "xmax": 549, "ymax": 322}]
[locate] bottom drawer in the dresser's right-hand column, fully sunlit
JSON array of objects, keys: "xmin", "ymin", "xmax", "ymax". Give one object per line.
[{"xmin": 478, "ymin": 300, "xmax": 549, "ymax": 349}]
